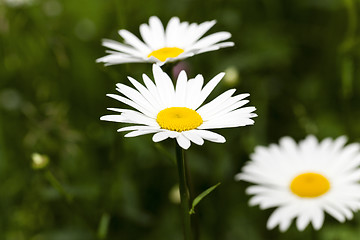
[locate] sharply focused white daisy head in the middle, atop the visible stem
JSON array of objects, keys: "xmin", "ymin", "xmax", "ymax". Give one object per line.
[{"xmin": 101, "ymin": 64, "xmax": 257, "ymax": 149}]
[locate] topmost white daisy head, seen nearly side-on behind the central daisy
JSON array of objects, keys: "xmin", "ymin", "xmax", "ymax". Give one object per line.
[{"xmin": 96, "ymin": 16, "xmax": 234, "ymax": 66}]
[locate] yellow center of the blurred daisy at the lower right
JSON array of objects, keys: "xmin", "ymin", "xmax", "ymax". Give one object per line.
[{"xmin": 290, "ymin": 172, "xmax": 330, "ymax": 198}]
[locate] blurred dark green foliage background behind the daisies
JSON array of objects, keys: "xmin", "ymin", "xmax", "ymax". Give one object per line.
[{"xmin": 0, "ymin": 0, "xmax": 360, "ymax": 240}]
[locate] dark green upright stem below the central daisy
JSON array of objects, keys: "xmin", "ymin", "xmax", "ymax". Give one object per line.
[{"xmin": 175, "ymin": 142, "xmax": 193, "ymax": 240}]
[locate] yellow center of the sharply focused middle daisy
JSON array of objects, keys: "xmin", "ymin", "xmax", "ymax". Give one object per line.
[{"xmin": 156, "ymin": 107, "xmax": 203, "ymax": 132}]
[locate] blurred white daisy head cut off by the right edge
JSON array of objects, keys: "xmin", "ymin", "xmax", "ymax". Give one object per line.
[{"xmin": 235, "ymin": 136, "xmax": 360, "ymax": 231}]
